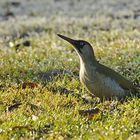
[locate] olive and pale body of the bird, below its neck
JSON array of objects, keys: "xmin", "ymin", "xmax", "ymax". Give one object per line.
[{"xmin": 80, "ymin": 62, "xmax": 137, "ymax": 98}]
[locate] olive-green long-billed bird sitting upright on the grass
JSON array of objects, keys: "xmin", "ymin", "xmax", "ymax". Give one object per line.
[{"xmin": 57, "ymin": 34, "xmax": 137, "ymax": 100}]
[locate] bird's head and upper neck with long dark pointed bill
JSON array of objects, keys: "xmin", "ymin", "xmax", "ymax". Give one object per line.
[{"xmin": 57, "ymin": 34, "xmax": 95, "ymax": 62}]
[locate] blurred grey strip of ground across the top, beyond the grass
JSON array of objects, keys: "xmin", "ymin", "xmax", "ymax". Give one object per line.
[{"xmin": 0, "ymin": 0, "xmax": 140, "ymax": 20}]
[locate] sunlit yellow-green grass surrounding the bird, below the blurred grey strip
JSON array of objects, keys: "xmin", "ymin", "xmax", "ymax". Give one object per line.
[{"xmin": 0, "ymin": 12, "xmax": 140, "ymax": 140}]
